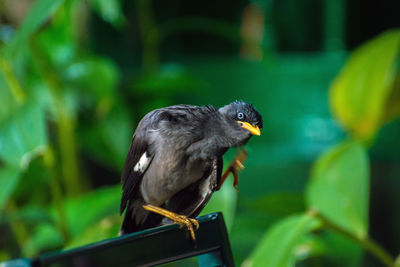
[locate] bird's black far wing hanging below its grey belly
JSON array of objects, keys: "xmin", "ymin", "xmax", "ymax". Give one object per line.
[{"xmin": 164, "ymin": 157, "xmax": 223, "ymax": 218}]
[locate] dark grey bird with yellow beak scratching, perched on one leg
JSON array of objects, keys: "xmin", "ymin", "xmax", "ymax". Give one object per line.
[{"xmin": 119, "ymin": 100, "xmax": 263, "ymax": 240}]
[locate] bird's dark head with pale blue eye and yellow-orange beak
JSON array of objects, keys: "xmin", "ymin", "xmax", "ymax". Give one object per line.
[{"xmin": 219, "ymin": 101, "xmax": 263, "ymax": 146}]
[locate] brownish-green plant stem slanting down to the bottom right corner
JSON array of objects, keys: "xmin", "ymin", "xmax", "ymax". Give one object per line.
[{"xmin": 312, "ymin": 212, "xmax": 394, "ymax": 267}]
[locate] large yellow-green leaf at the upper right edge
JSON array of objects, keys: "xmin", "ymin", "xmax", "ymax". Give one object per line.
[{"xmin": 330, "ymin": 30, "xmax": 400, "ymax": 138}]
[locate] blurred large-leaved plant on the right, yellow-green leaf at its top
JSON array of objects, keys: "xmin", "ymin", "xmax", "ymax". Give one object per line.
[{"xmin": 245, "ymin": 30, "xmax": 400, "ymax": 266}]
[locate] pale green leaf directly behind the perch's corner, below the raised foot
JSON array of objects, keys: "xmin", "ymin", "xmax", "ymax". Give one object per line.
[{"xmin": 200, "ymin": 181, "xmax": 237, "ymax": 231}]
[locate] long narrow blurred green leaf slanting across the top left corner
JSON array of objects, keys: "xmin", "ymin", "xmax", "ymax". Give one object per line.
[{"xmin": 3, "ymin": 0, "xmax": 64, "ymax": 58}]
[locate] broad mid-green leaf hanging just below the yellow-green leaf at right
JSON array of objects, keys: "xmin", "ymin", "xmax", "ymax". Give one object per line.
[{"xmin": 307, "ymin": 141, "xmax": 369, "ymax": 237}]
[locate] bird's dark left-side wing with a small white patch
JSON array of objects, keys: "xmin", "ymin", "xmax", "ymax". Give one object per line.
[{"xmin": 120, "ymin": 132, "xmax": 153, "ymax": 214}]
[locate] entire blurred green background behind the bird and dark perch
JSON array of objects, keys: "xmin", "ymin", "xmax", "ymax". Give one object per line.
[{"xmin": 0, "ymin": 0, "xmax": 400, "ymax": 266}]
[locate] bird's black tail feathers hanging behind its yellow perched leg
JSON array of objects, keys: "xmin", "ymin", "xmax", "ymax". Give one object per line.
[{"xmin": 118, "ymin": 199, "xmax": 163, "ymax": 236}]
